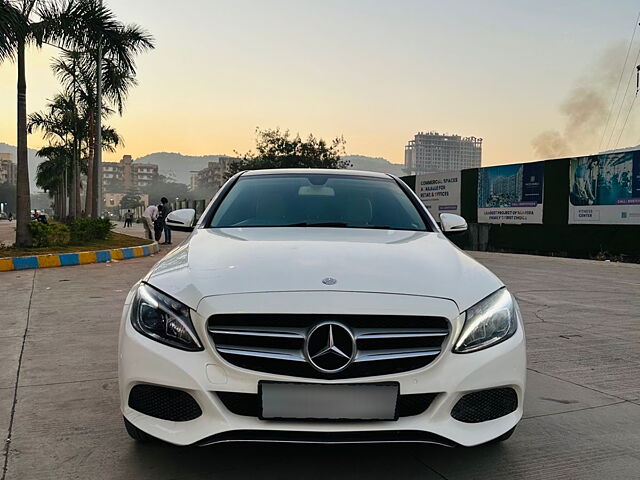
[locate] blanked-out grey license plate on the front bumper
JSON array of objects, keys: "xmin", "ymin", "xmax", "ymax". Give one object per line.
[{"xmin": 258, "ymin": 382, "xmax": 400, "ymax": 420}]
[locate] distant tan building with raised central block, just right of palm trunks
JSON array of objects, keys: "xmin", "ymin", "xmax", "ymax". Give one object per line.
[{"xmin": 102, "ymin": 155, "xmax": 158, "ymax": 192}]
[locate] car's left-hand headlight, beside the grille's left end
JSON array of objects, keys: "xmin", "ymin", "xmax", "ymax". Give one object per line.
[{"xmin": 131, "ymin": 284, "xmax": 202, "ymax": 352}]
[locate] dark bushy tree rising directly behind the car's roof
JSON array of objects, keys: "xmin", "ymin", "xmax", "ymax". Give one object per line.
[{"xmin": 227, "ymin": 128, "xmax": 351, "ymax": 176}]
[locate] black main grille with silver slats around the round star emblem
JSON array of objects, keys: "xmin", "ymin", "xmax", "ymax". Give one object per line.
[{"xmin": 208, "ymin": 314, "xmax": 449, "ymax": 379}]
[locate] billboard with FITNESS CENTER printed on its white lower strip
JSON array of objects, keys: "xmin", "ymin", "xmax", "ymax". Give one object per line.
[{"xmin": 569, "ymin": 151, "xmax": 640, "ymax": 225}]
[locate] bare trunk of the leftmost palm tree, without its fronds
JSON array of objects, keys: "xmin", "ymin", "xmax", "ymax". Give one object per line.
[{"xmin": 16, "ymin": 39, "xmax": 33, "ymax": 247}]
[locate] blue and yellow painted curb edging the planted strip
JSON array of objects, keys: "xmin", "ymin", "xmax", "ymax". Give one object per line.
[{"xmin": 0, "ymin": 242, "xmax": 160, "ymax": 272}]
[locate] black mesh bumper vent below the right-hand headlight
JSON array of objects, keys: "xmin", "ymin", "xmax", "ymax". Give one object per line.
[{"xmin": 451, "ymin": 387, "xmax": 518, "ymax": 423}]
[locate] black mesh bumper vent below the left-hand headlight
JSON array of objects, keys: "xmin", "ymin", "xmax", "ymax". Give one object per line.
[{"xmin": 129, "ymin": 385, "xmax": 202, "ymax": 422}]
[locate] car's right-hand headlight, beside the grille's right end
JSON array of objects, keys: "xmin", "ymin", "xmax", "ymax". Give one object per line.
[{"xmin": 453, "ymin": 288, "xmax": 520, "ymax": 353}]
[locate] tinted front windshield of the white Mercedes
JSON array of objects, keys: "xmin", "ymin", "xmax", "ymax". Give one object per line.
[{"xmin": 209, "ymin": 173, "xmax": 430, "ymax": 231}]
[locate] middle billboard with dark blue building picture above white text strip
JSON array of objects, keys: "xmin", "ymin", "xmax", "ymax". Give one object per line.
[{"xmin": 478, "ymin": 162, "xmax": 544, "ymax": 223}]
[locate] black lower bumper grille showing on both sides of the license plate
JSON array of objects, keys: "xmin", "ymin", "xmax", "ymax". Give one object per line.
[{"xmin": 216, "ymin": 392, "xmax": 438, "ymax": 417}]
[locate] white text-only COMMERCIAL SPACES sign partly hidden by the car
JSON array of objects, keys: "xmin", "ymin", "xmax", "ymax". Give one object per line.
[{"xmin": 416, "ymin": 171, "xmax": 460, "ymax": 220}]
